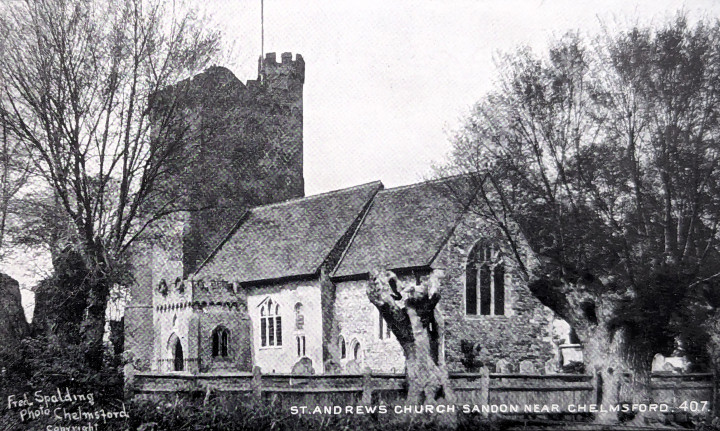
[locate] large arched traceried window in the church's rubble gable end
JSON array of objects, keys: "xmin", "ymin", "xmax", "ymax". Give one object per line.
[{"xmin": 465, "ymin": 242, "xmax": 505, "ymax": 316}]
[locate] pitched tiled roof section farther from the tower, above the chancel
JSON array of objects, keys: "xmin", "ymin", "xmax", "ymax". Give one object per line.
[{"xmin": 333, "ymin": 177, "xmax": 470, "ymax": 278}]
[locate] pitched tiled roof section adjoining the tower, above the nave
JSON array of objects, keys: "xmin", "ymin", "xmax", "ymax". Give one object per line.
[{"xmin": 196, "ymin": 181, "xmax": 383, "ymax": 283}]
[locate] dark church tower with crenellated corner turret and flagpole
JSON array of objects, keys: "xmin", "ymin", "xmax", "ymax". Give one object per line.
[{"xmin": 125, "ymin": 53, "xmax": 305, "ymax": 370}]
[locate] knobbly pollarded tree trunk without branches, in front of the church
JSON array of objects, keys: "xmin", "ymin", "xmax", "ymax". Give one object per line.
[{"xmin": 367, "ymin": 271, "xmax": 454, "ymax": 405}]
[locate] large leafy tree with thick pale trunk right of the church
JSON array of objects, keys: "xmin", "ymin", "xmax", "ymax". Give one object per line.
[{"xmin": 447, "ymin": 16, "xmax": 720, "ymax": 420}]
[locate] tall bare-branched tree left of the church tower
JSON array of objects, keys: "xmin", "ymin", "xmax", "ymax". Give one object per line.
[{"xmin": 0, "ymin": 0, "xmax": 218, "ymax": 367}]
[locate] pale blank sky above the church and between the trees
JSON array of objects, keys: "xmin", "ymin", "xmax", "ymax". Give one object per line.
[{"xmin": 2, "ymin": 0, "xmax": 720, "ymax": 313}]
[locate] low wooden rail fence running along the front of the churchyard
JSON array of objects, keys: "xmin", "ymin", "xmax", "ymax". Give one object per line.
[{"xmin": 134, "ymin": 368, "xmax": 715, "ymax": 413}]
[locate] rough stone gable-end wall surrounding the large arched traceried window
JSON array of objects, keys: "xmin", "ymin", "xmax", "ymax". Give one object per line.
[{"xmin": 433, "ymin": 216, "xmax": 556, "ymax": 371}]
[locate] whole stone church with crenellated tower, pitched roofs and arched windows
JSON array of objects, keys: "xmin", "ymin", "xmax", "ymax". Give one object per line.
[{"xmin": 125, "ymin": 53, "xmax": 561, "ymax": 382}]
